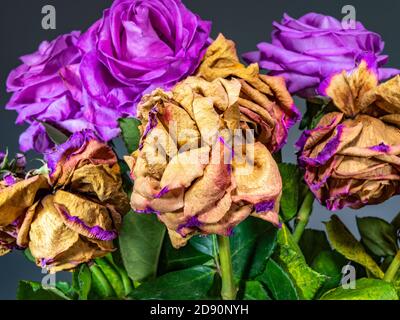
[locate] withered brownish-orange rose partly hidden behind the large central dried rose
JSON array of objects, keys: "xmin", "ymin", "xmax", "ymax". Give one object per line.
[{"xmin": 197, "ymin": 34, "xmax": 300, "ymax": 153}]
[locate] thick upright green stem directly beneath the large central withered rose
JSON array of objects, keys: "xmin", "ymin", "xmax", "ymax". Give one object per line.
[{"xmin": 218, "ymin": 236, "xmax": 237, "ymax": 300}]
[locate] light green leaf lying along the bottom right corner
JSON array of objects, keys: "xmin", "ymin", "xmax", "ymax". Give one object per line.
[{"xmin": 321, "ymin": 278, "xmax": 398, "ymax": 300}]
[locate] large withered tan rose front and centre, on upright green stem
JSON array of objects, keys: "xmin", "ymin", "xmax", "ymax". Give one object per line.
[{"xmin": 126, "ymin": 77, "xmax": 282, "ymax": 248}]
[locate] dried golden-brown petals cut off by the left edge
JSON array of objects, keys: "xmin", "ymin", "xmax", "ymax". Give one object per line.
[{"xmin": 0, "ymin": 175, "xmax": 50, "ymax": 255}]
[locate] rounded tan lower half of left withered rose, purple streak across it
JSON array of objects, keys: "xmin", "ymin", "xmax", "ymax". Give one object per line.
[{"xmin": 29, "ymin": 190, "xmax": 121, "ymax": 272}]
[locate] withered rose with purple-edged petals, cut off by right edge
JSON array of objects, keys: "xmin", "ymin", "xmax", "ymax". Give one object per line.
[{"xmin": 298, "ymin": 60, "xmax": 400, "ymax": 210}]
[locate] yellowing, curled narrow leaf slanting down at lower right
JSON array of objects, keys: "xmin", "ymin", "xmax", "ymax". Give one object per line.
[{"xmin": 326, "ymin": 215, "xmax": 384, "ymax": 279}]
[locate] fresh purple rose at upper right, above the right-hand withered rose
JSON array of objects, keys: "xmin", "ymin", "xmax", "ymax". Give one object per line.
[{"xmin": 244, "ymin": 13, "xmax": 400, "ymax": 98}]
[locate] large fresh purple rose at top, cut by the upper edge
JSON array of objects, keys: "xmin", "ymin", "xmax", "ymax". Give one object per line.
[{"xmin": 79, "ymin": 0, "xmax": 211, "ymax": 124}]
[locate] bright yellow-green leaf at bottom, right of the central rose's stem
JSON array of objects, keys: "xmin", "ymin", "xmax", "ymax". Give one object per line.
[{"xmin": 277, "ymin": 224, "xmax": 327, "ymax": 300}]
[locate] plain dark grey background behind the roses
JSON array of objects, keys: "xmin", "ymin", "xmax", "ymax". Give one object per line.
[{"xmin": 0, "ymin": 0, "xmax": 400, "ymax": 299}]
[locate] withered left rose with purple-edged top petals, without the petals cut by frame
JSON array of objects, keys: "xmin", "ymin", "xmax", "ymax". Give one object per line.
[{"xmin": 23, "ymin": 130, "xmax": 129, "ymax": 272}]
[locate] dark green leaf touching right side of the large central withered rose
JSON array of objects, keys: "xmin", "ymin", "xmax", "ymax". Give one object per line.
[{"xmin": 278, "ymin": 163, "xmax": 302, "ymax": 221}]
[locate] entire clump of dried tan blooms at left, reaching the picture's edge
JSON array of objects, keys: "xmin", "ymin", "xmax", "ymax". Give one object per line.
[{"xmin": 0, "ymin": 131, "xmax": 129, "ymax": 272}]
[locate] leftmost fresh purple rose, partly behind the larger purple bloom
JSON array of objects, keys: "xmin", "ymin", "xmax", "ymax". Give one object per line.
[{"xmin": 6, "ymin": 32, "xmax": 86, "ymax": 152}]
